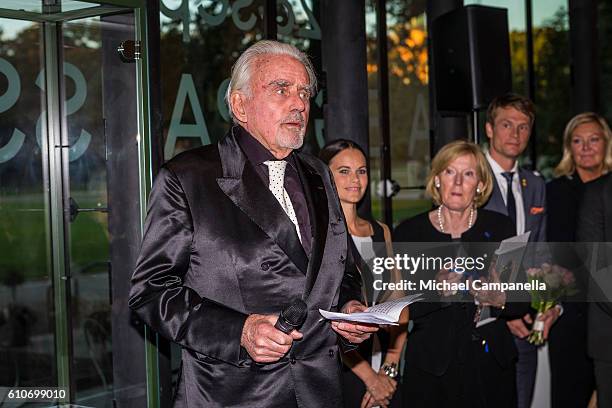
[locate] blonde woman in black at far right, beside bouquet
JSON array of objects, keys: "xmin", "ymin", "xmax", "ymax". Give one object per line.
[{"xmin": 546, "ymin": 112, "xmax": 612, "ymax": 408}]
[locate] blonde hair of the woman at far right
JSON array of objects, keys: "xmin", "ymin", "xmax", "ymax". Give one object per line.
[{"xmin": 554, "ymin": 112, "xmax": 612, "ymax": 177}]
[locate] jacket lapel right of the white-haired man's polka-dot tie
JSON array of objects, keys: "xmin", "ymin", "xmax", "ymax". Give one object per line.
[{"xmin": 296, "ymin": 154, "xmax": 329, "ymax": 299}]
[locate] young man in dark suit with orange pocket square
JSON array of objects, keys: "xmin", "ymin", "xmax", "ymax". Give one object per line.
[{"xmin": 485, "ymin": 94, "xmax": 561, "ymax": 408}]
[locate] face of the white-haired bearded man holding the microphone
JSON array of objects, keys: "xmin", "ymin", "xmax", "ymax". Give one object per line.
[{"xmin": 232, "ymin": 55, "xmax": 310, "ymax": 158}]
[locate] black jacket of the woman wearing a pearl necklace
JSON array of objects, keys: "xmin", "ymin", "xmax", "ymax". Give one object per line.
[{"xmin": 394, "ymin": 209, "xmax": 528, "ymax": 375}]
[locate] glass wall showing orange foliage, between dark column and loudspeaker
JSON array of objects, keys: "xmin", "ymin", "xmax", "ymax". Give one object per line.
[{"xmin": 366, "ymin": 0, "xmax": 431, "ymax": 223}]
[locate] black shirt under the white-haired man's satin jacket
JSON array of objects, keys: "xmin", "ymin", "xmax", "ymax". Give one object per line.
[{"xmin": 234, "ymin": 126, "xmax": 312, "ymax": 256}]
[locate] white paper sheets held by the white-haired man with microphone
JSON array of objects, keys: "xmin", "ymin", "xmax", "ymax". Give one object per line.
[{"xmin": 319, "ymin": 293, "xmax": 421, "ymax": 325}]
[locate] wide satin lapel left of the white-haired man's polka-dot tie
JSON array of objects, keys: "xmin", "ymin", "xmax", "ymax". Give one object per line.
[{"xmin": 217, "ymin": 131, "xmax": 308, "ymax": 274}]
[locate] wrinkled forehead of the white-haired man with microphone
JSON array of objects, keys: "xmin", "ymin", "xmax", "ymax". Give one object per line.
[{"xmin": 251, "ymin": 55, "xmax": 310, "ymax": 87}]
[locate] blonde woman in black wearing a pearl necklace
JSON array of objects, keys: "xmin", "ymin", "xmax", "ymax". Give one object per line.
[{"xmin": 395, "ymin": 141, "xmax": 527, "ymax": 408}]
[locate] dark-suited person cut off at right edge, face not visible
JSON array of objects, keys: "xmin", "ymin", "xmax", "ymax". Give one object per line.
[{"xmin": 576, "ymin": 174, "xmax": 612, "ymax": 407}]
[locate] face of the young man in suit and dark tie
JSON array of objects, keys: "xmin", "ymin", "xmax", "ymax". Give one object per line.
[{"xmin": 486, "ymin": 107, "xmax": 531, "ymax": 160}]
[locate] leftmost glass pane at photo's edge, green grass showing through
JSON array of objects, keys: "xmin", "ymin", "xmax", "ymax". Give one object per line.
[{"xmin": 0, "ymin": 19, "xmax": 56, "ymax": 388}]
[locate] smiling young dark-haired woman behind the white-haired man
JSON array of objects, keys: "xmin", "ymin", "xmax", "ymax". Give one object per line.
[{"xmin": 319, "ymin": 139, "xmax": 408, "ymax": 408}]
